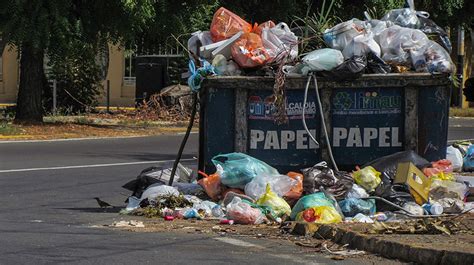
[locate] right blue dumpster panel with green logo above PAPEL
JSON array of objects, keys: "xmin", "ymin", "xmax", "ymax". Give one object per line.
[{"xmin": 331, "ymin": 88, "xmax": 404, "ymax": 164}]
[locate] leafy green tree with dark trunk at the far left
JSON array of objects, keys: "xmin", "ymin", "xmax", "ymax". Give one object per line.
[{"xmin": 0, "ymin": 0, "xmax": 154, "ymax": 122}]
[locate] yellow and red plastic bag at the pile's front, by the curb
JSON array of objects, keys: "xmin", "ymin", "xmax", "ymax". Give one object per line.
[{"xmin": 296, "ymin": 206, "xmax": 342, "ymax": 224}]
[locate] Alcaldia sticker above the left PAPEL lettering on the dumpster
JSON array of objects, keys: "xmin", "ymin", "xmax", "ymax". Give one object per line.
[{"xmin": 248, "ymin": 95, "xmax": 316, "ymax": 120}]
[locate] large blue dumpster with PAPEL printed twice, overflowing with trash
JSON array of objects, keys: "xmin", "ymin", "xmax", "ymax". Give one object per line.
[{"xmin": 199, "ymin": 73, "xmax": 451, "ymax": 173}]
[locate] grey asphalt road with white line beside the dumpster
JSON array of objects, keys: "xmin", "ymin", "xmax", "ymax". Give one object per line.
[{"xmin": 0, "ymin": 116, "xmax": 474, "ymax": 264}]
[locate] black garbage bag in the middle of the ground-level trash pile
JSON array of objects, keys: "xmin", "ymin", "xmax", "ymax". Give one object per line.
[{"xmin": 301, "ymin": 161, "xmax": 353, "ymax": 199}]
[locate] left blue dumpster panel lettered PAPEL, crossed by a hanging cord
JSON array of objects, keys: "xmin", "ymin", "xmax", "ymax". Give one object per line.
[{"xmin": 247, "ymin": 87, "xmax": 321, "ymax": 173}]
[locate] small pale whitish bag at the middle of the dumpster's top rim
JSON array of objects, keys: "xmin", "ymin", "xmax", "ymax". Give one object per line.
[{"xmin": 301, "ymin": 48, "xmax": 344, "ymax": 71}]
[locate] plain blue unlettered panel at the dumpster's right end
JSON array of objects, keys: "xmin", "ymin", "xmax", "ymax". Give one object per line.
[{"xmin": 418, "ymin": 86, "xmax": 450, "ymax": 161}]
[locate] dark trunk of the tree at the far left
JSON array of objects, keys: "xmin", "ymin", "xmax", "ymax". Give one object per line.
[{"xmin": 15, "ymin": 44, "xmax": 44, "ymax": 123}]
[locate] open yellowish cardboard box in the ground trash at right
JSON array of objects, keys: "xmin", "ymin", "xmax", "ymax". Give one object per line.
[{"xmin": 393, "ymin": 162, "xmax": 431, "ymax": 204}]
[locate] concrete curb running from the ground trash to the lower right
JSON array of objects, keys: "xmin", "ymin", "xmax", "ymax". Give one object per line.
[{"xmin": 292, "ymin": 223, "xmax": 474, "ymax": 265}]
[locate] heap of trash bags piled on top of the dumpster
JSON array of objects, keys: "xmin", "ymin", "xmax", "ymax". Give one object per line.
[{"xmin": 188, "ymin": 3, "xmax": 455, "ymax": 91}]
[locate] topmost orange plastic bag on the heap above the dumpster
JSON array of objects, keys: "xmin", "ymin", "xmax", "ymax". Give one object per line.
[{"xmin": 211, "ymin": 7, "xmax": 252, "ymax": 42}]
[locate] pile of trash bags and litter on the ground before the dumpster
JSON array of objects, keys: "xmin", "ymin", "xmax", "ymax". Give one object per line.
[{"xmin": 123, "ymin": 143, "xmax": 474, "ymax": 224}]
